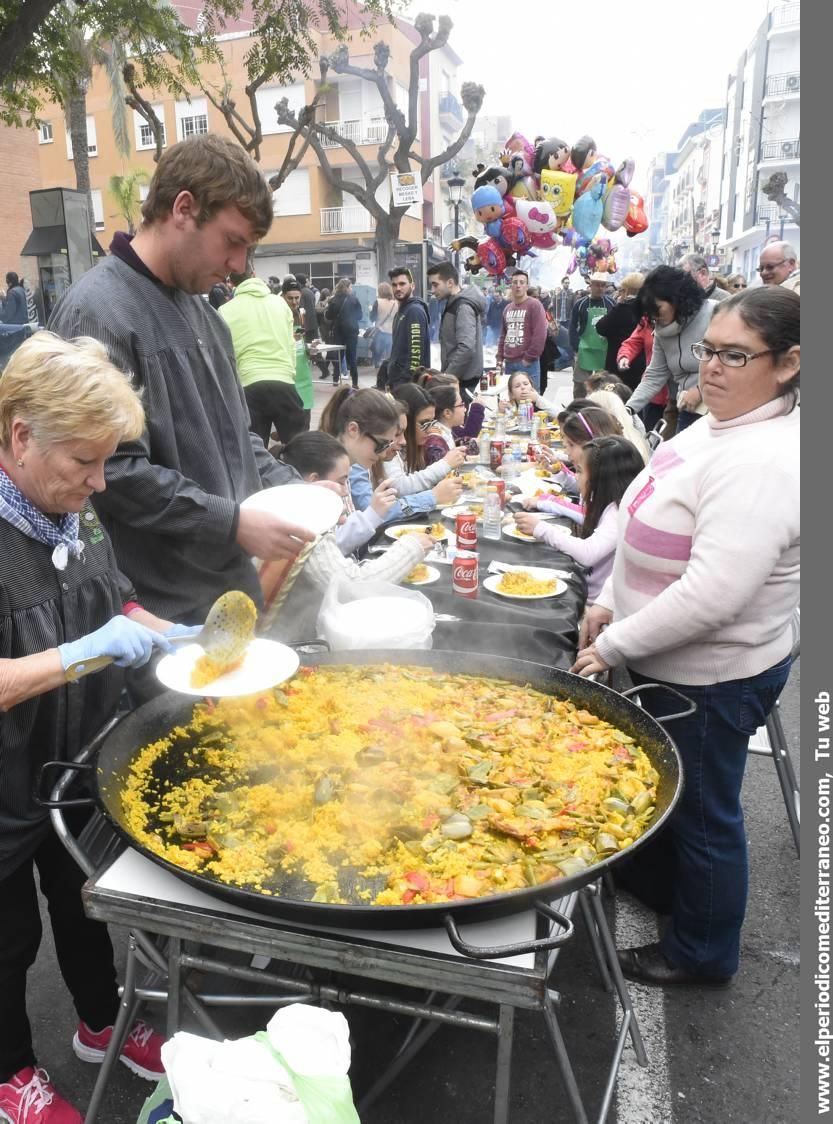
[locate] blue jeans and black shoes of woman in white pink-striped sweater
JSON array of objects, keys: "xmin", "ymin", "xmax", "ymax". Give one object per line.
[{"xmin": 617, "ymin": 656, "xmax": 791, "ymax": 976}]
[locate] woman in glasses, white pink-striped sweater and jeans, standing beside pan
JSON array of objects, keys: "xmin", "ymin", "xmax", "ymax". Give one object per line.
[{"xmin": 573, "ymin": 285, "xmax": 800, "ymax": 987}]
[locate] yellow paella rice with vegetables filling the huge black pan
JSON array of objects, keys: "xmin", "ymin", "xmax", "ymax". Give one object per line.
[{"xmin": 123, "ymin": 664, "xmax": 659, "ymax": 906}]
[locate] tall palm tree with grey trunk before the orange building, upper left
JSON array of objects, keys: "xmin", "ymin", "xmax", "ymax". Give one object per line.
[{"xmin": 61, "ymin": 0, "xmax": 130, "ymax": 232}]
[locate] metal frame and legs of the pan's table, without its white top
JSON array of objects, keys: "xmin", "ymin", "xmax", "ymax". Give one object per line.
[{"xmin": 78, "ymin": 878, "xmax": 648, "ymax": 1124}]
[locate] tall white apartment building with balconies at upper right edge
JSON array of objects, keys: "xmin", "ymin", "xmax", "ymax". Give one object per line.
[{"xmin": 721, "ymin": 3, "xmax": 802, "ymax": 278}]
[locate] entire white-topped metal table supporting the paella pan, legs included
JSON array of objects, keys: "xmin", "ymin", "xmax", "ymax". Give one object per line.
[{"xmin": 52, "ymin": 755, "xmax": 648, "ymax": 1124}]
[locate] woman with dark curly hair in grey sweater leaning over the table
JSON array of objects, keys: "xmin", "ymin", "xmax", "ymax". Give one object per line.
[{"xmin": 626, "ymin": 265, "xmax": 716, "ymax": 433}]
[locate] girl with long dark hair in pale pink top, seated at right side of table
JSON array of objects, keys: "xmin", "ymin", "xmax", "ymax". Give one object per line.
[{"xmin": 515, "ymin": 437, "xmax": 644, "ymax": 601}]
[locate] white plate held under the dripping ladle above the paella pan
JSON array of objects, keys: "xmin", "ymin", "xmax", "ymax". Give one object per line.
[{"xmin": 156, "ymin": 642, "xmax": 300, "ymax": 698}]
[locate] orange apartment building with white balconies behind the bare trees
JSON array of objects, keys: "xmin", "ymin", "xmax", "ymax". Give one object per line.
[{"xmin": 32, "ymin": 0, "xmax": 460, "ymax": 289}]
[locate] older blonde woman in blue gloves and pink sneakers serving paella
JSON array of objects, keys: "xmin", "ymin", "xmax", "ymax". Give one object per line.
[{"xmin": 0, "ymin": 332, "xmax": 172, "ymax": 1124}]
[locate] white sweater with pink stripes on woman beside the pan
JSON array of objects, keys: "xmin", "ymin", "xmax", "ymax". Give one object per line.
[{"xmin": 596, "ymin": 399, "xmax": 800, "ymax": 686}]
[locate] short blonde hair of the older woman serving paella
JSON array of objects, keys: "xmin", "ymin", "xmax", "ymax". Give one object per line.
[{"xmin": 0, "ymin": 332, "xmax": 145, "ymax": 448}]
